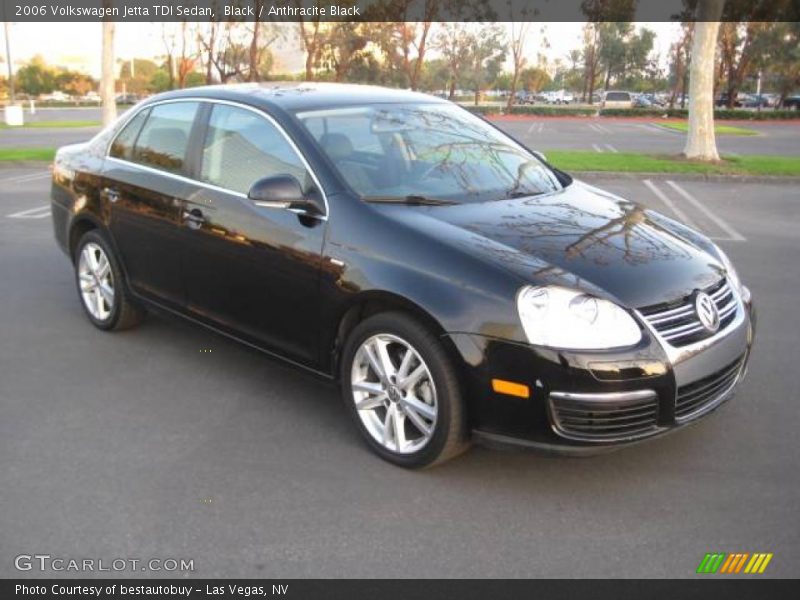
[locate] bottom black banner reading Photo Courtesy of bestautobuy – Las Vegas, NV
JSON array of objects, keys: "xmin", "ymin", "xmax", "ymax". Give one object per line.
[{"xmin": 0, "ymin": 578, "xmax": 800, "ymax": 600}]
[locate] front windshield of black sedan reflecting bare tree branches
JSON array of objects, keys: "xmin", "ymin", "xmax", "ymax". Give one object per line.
[{"xmin": 297, "ymin": 104, "xmax": 561, "ymax": 203}]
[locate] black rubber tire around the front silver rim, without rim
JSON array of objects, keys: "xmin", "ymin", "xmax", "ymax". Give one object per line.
[{"xmin": 340, "ymin": 312, "xmax": 469, "ymax": 469}]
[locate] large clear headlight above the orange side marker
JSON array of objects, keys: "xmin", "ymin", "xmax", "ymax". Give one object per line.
[{"xmin": 517, "ymin": 286, "xmax": 642, "ymax": 350}]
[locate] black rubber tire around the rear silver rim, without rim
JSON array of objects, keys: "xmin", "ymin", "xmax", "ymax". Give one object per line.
[{"xmin": 73, "ymin": 229, "xmax": 145, "ymax": 331}]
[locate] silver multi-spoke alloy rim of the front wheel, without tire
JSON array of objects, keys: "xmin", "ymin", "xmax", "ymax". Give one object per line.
[{"xmin": 350, "ymin": 333, "xmax": 438, "ymax": 454}]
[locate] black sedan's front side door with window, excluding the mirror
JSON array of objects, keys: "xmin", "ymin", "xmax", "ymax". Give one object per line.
[{"xmin": 182, "ymin": 103, "xmax": 326, "ymax": 365}]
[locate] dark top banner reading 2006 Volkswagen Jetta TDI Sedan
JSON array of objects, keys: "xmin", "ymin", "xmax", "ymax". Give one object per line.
[{"xmin": 0, "ymin": 0, "xmax": 800, "ymax": 22}]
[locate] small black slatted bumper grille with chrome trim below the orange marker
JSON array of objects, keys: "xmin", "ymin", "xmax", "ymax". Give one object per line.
[{"xmin": 550, "ymin": 390, "xmax": 658, "ymax": 441}]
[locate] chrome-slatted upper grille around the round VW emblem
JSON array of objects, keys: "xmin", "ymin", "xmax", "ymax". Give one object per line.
[{"xmin": 639, "ymin": 279, "xmax": 736, "ymax": 347}]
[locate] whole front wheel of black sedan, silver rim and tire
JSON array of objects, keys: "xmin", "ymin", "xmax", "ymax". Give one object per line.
[{"xmin": 341, "ymin": 312, "xmax": 469, "ymax": 468}]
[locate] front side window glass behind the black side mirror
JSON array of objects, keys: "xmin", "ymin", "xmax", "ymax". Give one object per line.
[{"xmin": 200, "ymin": 104, "xmax": 313, "ymax": 194}]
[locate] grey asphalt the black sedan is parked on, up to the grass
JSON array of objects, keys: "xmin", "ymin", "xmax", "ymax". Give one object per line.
[{"xmin": 0, "ymin": 163, "xmax": 800, "ymax": 578}]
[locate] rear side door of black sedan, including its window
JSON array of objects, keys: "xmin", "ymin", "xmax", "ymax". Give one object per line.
[{"xmin": 101, "ymin": 101, "xmax": 200, "ymax": 307}]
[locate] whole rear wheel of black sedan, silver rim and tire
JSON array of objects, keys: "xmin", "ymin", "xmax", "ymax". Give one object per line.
[{"xmin": 75, "ymin": 230, "xmax": 144, "ymax": 330}]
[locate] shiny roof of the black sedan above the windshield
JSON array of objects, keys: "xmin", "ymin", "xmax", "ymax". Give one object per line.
[{"xmin": 141, "ymin": 81, "xmax": 447, "ymax": 111}]
